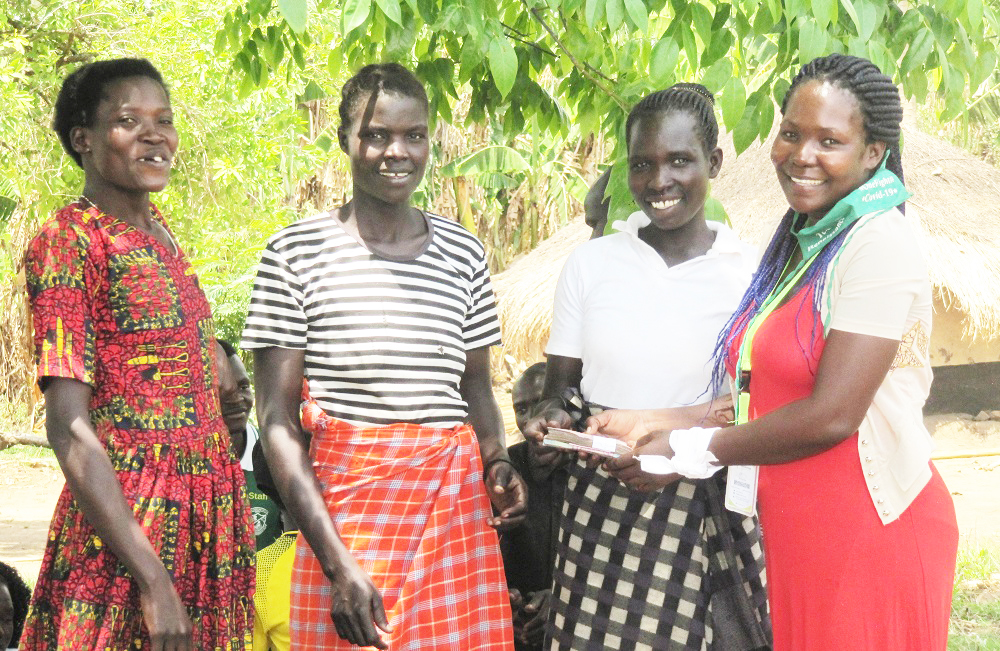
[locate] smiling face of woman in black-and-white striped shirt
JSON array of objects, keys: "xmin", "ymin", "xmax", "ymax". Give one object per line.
[{"xmin": 338, "ymin": 92, "xmax": 430, "ymax": 205}]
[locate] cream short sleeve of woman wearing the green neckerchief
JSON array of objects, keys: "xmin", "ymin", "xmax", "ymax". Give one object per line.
[{"xmin": 829, "ymin": 211, "xmax": 929, "ymax": 339}]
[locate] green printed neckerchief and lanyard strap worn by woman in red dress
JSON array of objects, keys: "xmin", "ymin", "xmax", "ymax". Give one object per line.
[{"xmin": 736, "ymin": 153, "xmax": 910, "ymax": 425}]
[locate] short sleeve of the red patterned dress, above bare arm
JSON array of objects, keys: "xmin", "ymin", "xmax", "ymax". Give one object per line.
[{"xmin": 25, "ymin": 217, "xmax": 100, "ymax": 391}]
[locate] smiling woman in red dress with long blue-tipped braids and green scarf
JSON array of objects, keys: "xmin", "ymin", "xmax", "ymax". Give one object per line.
[{"xmin": 593, "ymin": 54, "xmax": 958, "ymax": 651}]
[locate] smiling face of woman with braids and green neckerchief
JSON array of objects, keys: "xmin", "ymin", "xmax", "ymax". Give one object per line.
[{"xmin": 771, "ymin": 80, "xmax": 885, "ymax": 223}]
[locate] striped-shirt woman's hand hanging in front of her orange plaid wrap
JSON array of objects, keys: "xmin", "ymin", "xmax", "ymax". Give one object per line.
[{"xmin": 328, "ymin": 555, "xmax": 392, "ymax": 649}]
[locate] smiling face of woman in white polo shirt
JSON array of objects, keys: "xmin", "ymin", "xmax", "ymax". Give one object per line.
[{"xmin": 628, "ymin": 111, "xmax": 722, "ymax": 231}]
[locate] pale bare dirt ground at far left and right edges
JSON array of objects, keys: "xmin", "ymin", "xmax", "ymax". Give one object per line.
[{"xmin": 0, "ymin": 415, "xmax": 1000, "ymax": 579}]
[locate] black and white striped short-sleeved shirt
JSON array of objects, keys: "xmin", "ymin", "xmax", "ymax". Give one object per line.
[{"xmin": 242, "ymin": 213, "xmax": 500, "ymax": 427}]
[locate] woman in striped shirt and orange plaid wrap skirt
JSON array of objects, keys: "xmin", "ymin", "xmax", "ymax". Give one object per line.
[{"xmin": 243, "ymin": 63, "xmax": 527, "ymax": 649}]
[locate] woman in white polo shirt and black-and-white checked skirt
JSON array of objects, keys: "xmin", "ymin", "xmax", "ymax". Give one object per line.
[{"xmin": 526, "ymin": 84, "xmax": 767, "ymax": 650}]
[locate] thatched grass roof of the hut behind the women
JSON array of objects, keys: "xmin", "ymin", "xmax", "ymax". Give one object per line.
[{"xmin": 494, "ymin": 124, "xmax": 1000, "ymax": 370}]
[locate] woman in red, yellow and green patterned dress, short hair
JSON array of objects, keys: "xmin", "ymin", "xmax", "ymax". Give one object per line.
[{"xmin": 21, "ymin": 59, "xmax": 254, "ymax": 651}]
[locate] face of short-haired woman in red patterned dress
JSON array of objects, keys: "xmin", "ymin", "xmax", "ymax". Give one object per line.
[{"xmin": 70, "ymin": 77, "xmax": 177, "ymax": 195}]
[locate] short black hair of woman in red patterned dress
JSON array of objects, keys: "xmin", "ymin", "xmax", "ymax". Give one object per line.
[{"xmin": 52, "ymin": 57, "xmax": 170, "ymax": 167}]
